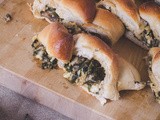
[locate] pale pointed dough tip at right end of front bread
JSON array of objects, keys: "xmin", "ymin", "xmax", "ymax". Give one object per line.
[{"xmin": 118, "ymin": 57, "xmax": 145, "ymax": 91}]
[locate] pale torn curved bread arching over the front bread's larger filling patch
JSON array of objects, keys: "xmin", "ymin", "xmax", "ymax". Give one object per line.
[{"xmin": 75, "ymin": 34, "xmax": 119, "ymax": 103}]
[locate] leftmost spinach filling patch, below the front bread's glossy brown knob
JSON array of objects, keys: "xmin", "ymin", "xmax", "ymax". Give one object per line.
[{"xmin": 32, "ymin": 39, "xmax": 57, "ymax": 69}]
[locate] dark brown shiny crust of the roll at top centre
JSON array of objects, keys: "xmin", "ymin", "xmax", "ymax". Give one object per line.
[{"xmin": 62, "ymin": 0, "xmax": 96, "ymax": 22}]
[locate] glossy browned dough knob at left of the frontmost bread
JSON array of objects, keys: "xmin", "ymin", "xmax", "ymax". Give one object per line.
[{"xmin": 38, "ymin": 22, "xmax": 74, "ymax": 62}]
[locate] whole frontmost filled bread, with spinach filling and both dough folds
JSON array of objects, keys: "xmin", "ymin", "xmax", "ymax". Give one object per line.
[{"xmin": 32, "ymin": 22, "xmax": 145, "ymax": 104}]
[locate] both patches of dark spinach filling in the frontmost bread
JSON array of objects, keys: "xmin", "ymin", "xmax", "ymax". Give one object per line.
[{"xmin": 32, "ymin": 39, "xmax": 105, "ymax": 94}]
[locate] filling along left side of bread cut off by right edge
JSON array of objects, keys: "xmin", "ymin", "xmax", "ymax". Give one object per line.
[{"xmin": 147, "ymin": 56, "xmax": 160, "ymax": 103}]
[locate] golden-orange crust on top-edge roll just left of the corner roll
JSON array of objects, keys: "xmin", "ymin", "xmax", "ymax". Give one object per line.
[{"xmin": 115, "ymin": 0, "xmax": 140, "ymax": 24}]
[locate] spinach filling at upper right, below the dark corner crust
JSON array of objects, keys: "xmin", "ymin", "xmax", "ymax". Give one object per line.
[{"xmin": 142, "ymin": 24, "xmax": 160, "ymax": 48}]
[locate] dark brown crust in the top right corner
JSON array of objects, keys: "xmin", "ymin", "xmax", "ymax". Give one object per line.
[{"xmin": 139, "ymin": 2, "xmax": 160, "ymax": 21}]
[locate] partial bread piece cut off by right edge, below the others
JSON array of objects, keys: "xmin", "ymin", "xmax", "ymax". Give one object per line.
[{"xmin": 148, "ymin": 47, "xmax": 160, "ymax": 103}]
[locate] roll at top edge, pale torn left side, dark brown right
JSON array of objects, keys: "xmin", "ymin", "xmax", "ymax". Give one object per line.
[{"xmin": 32, "ymin": 0, "xmax": 96, "ymax": 24}]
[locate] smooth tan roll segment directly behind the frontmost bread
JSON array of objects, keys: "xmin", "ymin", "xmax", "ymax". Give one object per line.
[{"xmin": 82, "ymin": 9, "xmax": 125, "ymax": 44}]
